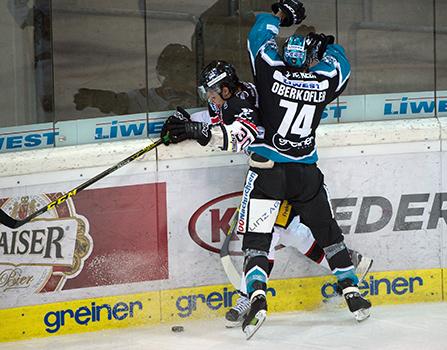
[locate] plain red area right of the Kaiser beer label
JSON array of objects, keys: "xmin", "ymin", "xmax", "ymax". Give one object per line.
[{"xmin": 64, "ymin": 183, "xmax": 168, "ymax": 289}]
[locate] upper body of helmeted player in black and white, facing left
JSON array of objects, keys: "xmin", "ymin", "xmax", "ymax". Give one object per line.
[{"xmin": 161, "ymin": 61, "xmax": 259, "ymax": 152}]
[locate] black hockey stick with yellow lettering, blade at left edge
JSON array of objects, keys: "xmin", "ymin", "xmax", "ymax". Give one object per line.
[{"xmin": 0, "ymin": 135, "xmax": 169, "ymax": 228}]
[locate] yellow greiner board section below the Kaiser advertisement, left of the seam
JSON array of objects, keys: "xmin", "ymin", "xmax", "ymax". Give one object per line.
[{"xmin": 0, "ymin": 292, "xmax": 161, "ymax": 342}]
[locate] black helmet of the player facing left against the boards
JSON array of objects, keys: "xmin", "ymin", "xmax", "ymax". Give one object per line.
[{"xmin": 198, "ymin": 61, "xmax": 239, "ymax": 100}]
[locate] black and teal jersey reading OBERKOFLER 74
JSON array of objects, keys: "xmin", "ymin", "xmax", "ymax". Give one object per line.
[{"xmin": 248, "ymin": 14, "xmax": 351, "ymax": 164}]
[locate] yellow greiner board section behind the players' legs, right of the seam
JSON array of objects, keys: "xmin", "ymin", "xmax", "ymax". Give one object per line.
[{"xmin": 160, "ymin": 269, "xmax": 443, "ymax": 322}]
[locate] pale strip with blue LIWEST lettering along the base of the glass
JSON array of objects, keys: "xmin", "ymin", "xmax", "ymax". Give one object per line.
[{"xmin": 0, "ymin": 91, "xmax": 447, "ymax": 153}]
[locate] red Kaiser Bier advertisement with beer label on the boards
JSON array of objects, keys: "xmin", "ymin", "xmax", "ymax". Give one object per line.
[{"xmin": 0, "ymin": 183, "xmax": 169, "ymax": 308}]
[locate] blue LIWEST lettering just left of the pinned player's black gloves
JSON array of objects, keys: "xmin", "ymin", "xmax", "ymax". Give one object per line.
[{"xmin": 95, "ymin": 119, "xmax": 164, "ymax": 140}]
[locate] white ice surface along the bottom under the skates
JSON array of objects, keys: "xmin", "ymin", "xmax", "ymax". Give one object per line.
[{"xmin": 0, "ymin": 303, "xmax": 447, "ymax": 350}]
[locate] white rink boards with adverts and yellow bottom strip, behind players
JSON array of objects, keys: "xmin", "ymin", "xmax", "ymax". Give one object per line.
[{"xmin": 0, "ymin": 118, "xmax": 447, "ymax": 341}]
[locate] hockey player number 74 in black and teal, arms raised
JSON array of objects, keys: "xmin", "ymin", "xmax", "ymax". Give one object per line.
[{"xmin": 237, "ymin": 0, "xmax": 371, "ymax": 338}]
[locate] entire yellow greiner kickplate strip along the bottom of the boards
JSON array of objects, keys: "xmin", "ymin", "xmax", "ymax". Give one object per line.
[{"xmin": 0, "ymin": 269, "xmax": 447, "ymax": 341}]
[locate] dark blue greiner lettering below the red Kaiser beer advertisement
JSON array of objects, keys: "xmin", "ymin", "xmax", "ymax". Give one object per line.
[{"xmin": 43, "ymin": 301, "xmax": 143, "ymax": 333}]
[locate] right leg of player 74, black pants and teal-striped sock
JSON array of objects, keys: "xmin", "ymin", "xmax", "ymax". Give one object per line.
[{"xmin": 288, "ymin": 166, "xmax": 371, "ymax": 321}]
